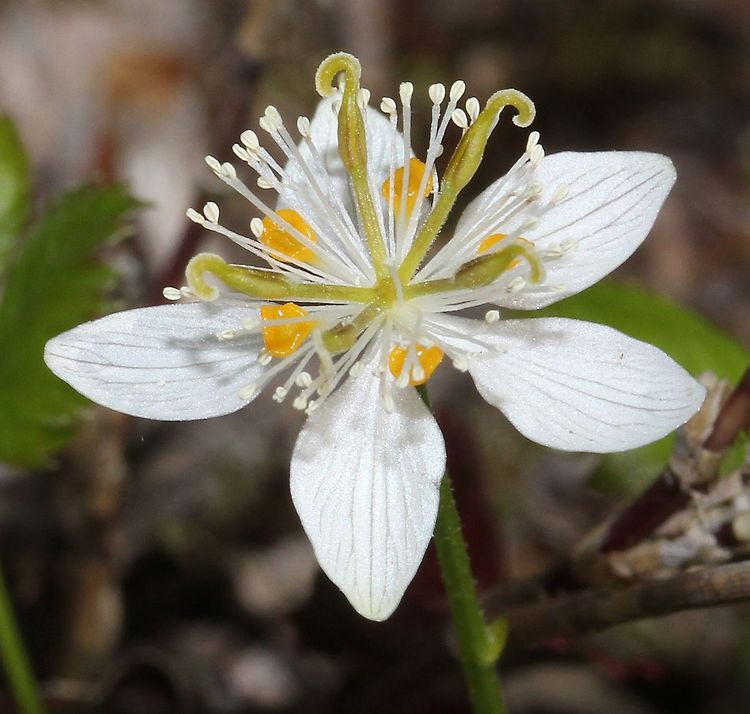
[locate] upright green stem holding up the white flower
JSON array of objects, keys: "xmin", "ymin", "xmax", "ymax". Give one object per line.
[{"xmin": 417, "ymin": 386, "xmax": 507, "ymax": 714}]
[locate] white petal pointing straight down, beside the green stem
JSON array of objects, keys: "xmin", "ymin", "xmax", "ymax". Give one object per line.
[{"xmin": 291, "ymin": 356, "xmax": 445, "ymax": 620}]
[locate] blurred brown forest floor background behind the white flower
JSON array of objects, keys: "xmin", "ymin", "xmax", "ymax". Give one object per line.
[{"xmin": 0, "ymin": 0, "xmax": 750, "ymax": 714}]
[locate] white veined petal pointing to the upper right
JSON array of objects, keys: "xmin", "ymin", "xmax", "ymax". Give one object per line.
[{"xmin": 456, "ymin": 151, "xmax": 675, "ymax": 310}]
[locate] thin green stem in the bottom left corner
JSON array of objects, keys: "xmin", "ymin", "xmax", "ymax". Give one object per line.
[{"xmin": 0, "ymin": 568, "xmax": 46, "ymax": 714}]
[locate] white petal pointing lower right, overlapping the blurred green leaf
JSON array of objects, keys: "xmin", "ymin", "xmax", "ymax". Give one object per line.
[{"xmin": 432, "ymin": 317, "xmax": 705, "ymax": 453}]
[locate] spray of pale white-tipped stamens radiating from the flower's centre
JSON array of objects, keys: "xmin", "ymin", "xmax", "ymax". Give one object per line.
[{"xmin": 164, "ymin": 55, "xmax": 556, "ymax": 413}]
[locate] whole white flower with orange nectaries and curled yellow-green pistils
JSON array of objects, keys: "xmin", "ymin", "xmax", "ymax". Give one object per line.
[{"xmin": 45, "ymin": 54, "xmax": 704, "ymax": 620}]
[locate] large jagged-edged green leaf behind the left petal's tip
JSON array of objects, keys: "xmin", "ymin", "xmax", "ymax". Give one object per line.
[{"xmin": 0, "ymin": 182, "xmax": 138, "ymax": 466}]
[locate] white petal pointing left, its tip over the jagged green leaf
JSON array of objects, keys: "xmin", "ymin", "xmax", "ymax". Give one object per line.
[{"xmin": 44, "ymin": 303, "xmax": 263, "ymax": 421}]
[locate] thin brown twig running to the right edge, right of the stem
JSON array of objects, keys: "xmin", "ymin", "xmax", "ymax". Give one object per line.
[{"xmin": 504, "ymin": 561, "xmax": 750, "ymax": 650}]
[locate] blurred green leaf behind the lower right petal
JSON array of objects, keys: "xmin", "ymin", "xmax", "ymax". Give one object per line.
[{"xmin": 514, "ymin": 281, "xmax": 750, "ymax": 491}]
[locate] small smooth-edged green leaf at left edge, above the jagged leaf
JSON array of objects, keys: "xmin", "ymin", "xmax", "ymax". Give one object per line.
[{"xmin": 0, "ymin": 116, "xmax": 29, "ymax": 275}]
